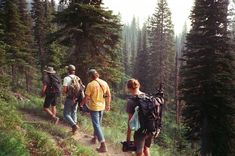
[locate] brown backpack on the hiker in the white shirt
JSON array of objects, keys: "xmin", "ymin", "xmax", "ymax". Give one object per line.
[{"xmin": 67, "ymin": 76, "xmax": 84, "ymax": 100}]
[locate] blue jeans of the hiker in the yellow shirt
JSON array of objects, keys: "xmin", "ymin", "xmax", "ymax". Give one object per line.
[{"xmin": 90, "ymin": 111, "xmax": 105, "ymax": 142}]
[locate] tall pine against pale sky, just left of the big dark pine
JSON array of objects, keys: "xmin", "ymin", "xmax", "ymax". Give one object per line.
[{"xmin": 148, "ymin": 0, "xmax": 175, "ymax": 95}]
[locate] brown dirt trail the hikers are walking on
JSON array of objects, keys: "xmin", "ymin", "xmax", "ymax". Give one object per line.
[{"xmin": 23, "ymin": 112, "xmax": 133, "ymax": 156}]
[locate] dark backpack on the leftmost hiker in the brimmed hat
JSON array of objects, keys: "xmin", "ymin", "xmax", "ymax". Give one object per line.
[{"xmin": 47, "ymin": 74, "xmax": 61, "ymax": 95}]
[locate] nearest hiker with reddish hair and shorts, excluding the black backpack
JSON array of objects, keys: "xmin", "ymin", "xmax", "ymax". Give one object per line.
[{"xmin": 126, "ymin": 79, "xmax": 153, "ymax": 156}]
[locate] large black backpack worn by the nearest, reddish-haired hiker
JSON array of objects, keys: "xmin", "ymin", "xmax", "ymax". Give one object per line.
[{"xmin": 136, "ymin": 94, "xmax": 163, "ymax": 133}]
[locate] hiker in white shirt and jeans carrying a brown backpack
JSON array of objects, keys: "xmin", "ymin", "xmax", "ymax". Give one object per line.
[{"xmin": 63, "ymin": 65, "xmax": 83, "ymax": 134}]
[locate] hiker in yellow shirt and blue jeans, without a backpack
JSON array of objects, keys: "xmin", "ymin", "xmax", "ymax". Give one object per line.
[{"xmin": 81, "ymin": 69, "xmax": 111, "ymax": 153}]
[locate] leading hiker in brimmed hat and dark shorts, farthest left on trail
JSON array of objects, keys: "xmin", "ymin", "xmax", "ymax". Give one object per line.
[{"xmin": 41, "ymin": 67, "xmax": 61, "ymax": 124}]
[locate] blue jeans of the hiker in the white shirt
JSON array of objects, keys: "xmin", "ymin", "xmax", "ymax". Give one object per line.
[{"xmin": 64, "ymin": 97, "xmax": 78, "ymax": 126}]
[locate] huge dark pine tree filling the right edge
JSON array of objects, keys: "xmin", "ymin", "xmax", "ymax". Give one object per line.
[{"xmin": 181, "ymin": 0, "xmax": 235, "ymax": 156}]
